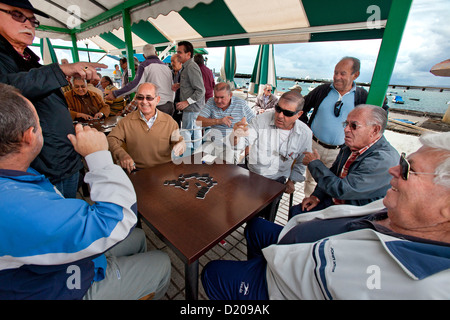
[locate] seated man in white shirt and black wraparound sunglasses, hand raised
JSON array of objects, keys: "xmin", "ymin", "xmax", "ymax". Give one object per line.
[{"xmin": 230, "ymin": 90, "xmax": 312, "ymax": 221}]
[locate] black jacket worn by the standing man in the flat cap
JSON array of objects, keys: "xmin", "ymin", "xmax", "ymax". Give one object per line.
[{"xmin": 0, "ymin": 36, "xmax": 83, "ymax": 183}]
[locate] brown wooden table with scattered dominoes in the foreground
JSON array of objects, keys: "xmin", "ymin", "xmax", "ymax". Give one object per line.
[{"xmin": 130, "ymin": 158, "xmax": 285, "ymax": 299}]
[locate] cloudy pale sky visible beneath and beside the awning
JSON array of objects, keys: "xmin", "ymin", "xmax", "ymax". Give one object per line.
[{"xmin": 207, "ymin": 0, "xmax": 450, "ymax": 87}]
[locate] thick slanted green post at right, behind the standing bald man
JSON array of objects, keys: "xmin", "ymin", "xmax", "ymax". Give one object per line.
[{"xmin": 367, "ymin": 0, "xmax": 413, "ymax": 107}]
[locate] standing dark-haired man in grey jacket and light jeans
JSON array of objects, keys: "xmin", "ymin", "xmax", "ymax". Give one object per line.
[{"xmin": 172, "ymin": 41, "xmax": 205, "ymax": 150}]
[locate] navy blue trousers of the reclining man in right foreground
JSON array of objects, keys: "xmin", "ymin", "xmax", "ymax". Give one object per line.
[{"xmin": 202, "ymin": 218, "xmax": 283, "ymax": 300}]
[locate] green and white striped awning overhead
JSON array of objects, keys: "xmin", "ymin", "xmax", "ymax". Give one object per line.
[{"xmin": 31, "ymin": 0, "xmax": 392, "ymax": 54}]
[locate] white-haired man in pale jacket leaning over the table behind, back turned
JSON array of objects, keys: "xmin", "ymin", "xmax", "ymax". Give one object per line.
[{"xmin": 105, "ymin": 44, "xmax": 175, "ymax": 116}]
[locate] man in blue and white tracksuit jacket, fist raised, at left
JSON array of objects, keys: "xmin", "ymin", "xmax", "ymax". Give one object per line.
[{"xmin": 0, "ymin": 84, "xmax": 170, "ymax": 300}]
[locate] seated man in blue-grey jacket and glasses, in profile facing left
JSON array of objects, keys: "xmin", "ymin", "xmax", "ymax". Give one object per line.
[{"xmin": 289, "ymin": 105, "xmax": 399, "ymax": 217}]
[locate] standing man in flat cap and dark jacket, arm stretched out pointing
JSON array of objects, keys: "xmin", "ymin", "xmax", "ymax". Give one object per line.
[{"xmin": 0, "ymin": 0, "xmax": 107, "ymax": 198}]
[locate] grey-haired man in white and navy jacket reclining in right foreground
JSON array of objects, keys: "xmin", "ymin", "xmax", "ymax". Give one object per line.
[{"xmin": 202, "ymin": 132, "xmax": 450, "ymax": 300}]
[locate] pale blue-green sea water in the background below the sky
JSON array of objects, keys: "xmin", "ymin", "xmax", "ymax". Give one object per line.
[{"xmin": 235, "ymin": 78, "xmax": 450, "ymax": 114}]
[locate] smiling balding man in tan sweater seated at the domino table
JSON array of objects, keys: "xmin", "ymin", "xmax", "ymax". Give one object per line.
[{"xmin": 108, "ymin": 82, "xmax": 186, "ymax": 172}]
